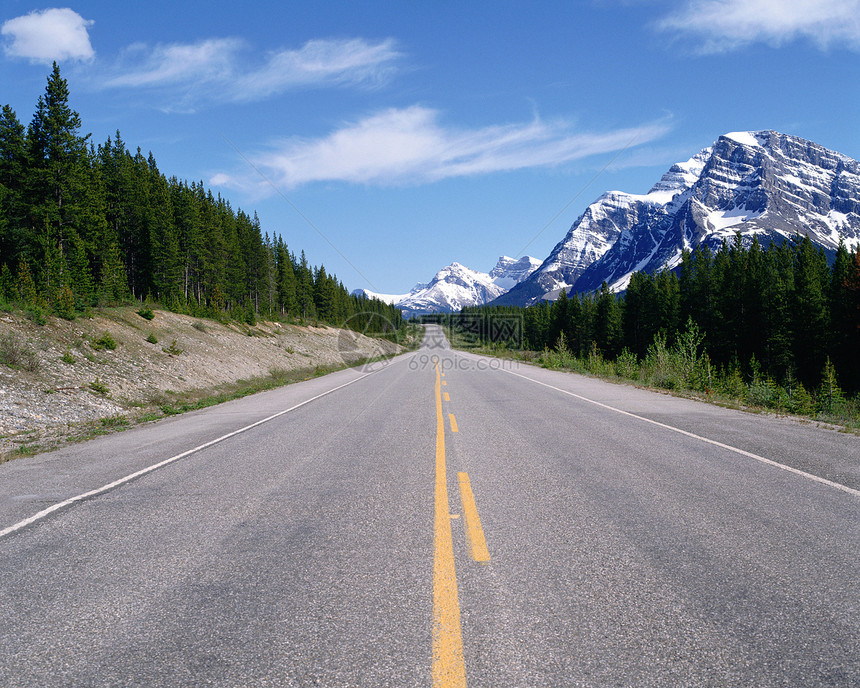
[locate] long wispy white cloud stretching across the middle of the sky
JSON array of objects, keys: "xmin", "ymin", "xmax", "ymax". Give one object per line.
[{"xmin": 211, "ymin": 106, "xmax": 669, "ymax": 190}]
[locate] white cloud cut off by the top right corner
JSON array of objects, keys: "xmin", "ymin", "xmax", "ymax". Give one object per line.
[{"xmin": 657, "ymin": 0, "xmax": 860, "ymax": 53}]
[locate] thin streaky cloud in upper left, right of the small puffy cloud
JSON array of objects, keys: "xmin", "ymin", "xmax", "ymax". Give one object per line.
[{"xmin": 102, "ymin": 38, "xmax": 400, "ymax": 107}]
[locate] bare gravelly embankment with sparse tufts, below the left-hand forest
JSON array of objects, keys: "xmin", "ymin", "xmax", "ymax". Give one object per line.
[{"xmin": 0, "ymin": 307, "xmax": 403, "ymax": 461}]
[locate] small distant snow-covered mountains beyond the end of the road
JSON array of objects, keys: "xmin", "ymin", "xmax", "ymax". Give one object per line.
[{"xmin": 353, "ymin": 256, "xmax": 540, "ymax": 316}]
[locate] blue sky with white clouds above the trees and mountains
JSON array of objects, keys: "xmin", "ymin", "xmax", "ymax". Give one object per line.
[{"xmin": 0, "ymin": 0, "xmax": 860, "ymax": 293}]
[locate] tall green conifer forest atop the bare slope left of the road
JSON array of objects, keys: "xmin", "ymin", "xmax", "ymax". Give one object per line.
[{"xmin": 0, "ymin": 63, "xmax": 402, "ymax": 332}]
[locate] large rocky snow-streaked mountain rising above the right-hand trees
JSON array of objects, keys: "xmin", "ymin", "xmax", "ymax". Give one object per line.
[{"xmin": 496, "ymin": 131, "xmax": 860, "ymax": 304}]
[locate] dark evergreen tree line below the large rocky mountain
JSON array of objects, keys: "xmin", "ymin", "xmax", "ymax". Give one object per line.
[{"xmin": 452, "ymin": 234, "xmax": 860, "ymax": 393}]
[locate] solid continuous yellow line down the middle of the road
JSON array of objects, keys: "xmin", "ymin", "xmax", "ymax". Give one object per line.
[{"xmin": 433, "ymin": 359, "xmax": 466, "ymax": 688}]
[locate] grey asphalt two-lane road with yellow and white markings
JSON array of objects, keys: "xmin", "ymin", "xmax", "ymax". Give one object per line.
[{"xmin": 0, "ymin": 328, "xmax": 860, "ymax": 687}]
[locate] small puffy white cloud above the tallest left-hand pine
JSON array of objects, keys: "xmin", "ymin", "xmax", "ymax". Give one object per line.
[{"xmin": 0, "ymin": 8, "xmax": 95, "ymax": 62}]
